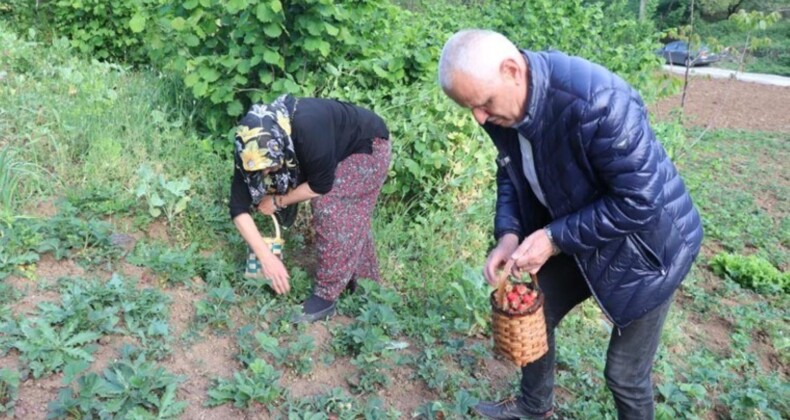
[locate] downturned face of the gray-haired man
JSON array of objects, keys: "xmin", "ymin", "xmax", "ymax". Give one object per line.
[{"xmin": 446, "ymin": 62, "xmax": 526, "ymax": 127}]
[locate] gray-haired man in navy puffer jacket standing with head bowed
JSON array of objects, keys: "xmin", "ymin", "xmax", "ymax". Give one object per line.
[{"xmin": 439, "ymin": 30, "xmax": 702, "ymax": 419}]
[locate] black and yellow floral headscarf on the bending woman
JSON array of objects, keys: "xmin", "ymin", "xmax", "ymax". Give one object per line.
[{"xmin": 234, "ymin": 95, "xmax": 299, "ymax": 205}]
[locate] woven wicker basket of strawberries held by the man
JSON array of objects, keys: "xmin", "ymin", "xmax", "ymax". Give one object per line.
[{"xmin": 491, "ymin": 260, "xmax": 549, "ymax": 367}]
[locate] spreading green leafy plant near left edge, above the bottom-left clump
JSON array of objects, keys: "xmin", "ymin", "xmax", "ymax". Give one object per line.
[{"xmin": 13, "ymin": 318, "xmax": 101, "ymax": 378}]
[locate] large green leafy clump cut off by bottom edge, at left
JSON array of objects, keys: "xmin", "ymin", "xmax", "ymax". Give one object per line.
[{"xmin": 47, "ymin": 346, "xmax": 187, "ymax": 419}]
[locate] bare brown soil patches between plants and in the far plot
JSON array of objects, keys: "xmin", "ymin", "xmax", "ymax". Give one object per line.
[{"xmin": 7, "ymin": 79, "xmax": 790, "ymax": 420}]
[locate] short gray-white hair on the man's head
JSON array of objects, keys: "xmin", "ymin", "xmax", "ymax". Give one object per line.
[{"xmin": 439, "ymin": 29, "xmax": 521, "ymax": 92}]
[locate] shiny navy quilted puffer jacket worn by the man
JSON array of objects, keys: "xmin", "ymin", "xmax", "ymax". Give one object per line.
[{"xmin": 484, "ymin": 51, "xmax": 702, "ymax": 327}]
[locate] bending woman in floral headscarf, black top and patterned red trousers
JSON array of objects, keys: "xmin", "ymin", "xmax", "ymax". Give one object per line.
[{"xmin": 230, "ymin": 95, "xmax": 391, "ymax": 322}]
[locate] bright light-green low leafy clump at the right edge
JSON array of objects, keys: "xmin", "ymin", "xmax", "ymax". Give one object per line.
[{"xmin": 710, "ymin": 252, "xmax": 790, "ymax": 294}]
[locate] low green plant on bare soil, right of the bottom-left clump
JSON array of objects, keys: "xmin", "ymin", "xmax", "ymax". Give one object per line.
[{"xmin": 206, "ymin": 359, "xmax": 283, "ymax": 408}]
